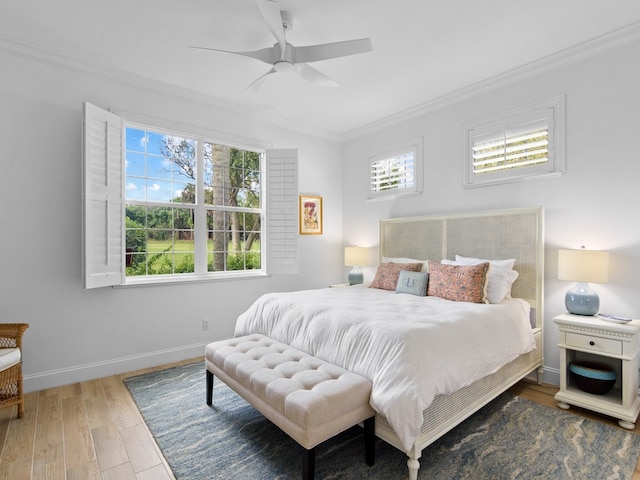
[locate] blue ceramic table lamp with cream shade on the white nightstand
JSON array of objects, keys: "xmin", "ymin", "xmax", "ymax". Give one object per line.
[{"xmin": 558, "ymin": 247, "xmax": 609, "ymax": 315}]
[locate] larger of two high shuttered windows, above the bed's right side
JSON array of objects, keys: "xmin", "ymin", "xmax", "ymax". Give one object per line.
[{"xmin": 463, "ymin": 97, "xmax": 564, "ymax": 187}]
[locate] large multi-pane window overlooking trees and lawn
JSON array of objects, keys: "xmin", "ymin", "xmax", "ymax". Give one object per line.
[{"xmin": 125, "ymin": 125, "xmax": 262, "ymax": 277}]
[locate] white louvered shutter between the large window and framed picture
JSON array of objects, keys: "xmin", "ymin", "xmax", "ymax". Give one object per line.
[{"xmin": 266, "ymin": 149, "xmax": 299, "ymax": 273}]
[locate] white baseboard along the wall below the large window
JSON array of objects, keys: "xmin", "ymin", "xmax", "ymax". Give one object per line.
[{"xmin": 24, "ymin": 343, "xmax": 206, "ymax": 393}]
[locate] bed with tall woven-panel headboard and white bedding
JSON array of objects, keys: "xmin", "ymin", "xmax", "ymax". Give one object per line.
[{"xmin": 235, "ymin": 208, "xmax": 544, "ymax": 480}]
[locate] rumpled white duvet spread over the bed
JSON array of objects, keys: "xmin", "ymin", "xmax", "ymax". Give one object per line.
[{"xmin": 235, "ymin": 287, "xmax": 535, "ymax": 450}]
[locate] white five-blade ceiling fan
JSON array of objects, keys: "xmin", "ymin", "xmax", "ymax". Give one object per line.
[{"xmin": 191, "ymin": 0, "xmax": 373, "ymax": 91}]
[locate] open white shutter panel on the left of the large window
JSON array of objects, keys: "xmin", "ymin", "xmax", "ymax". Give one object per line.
[{"xmin": 83, "ymin": 103, "xmax": 124, "ymax": 288}]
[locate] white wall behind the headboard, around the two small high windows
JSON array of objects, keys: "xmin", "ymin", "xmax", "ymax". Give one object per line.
[{"xmin": 343, "ymin": 37, "xmax": 640, "ymax": 383}]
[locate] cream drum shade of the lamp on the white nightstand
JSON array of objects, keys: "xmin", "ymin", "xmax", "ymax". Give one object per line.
[{"xmin": 558, "ymin": 250, "xmax": 609, "ymax": 283}]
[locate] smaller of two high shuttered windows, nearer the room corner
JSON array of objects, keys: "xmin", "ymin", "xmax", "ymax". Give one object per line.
[{"xmin": 368, "ymin": 138, "xmax": 422, "ymax": 199}]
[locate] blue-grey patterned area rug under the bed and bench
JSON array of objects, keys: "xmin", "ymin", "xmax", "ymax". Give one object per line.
[{"xmin": 125, "ymin": 363, "xmax": 640, "ymax": 480}]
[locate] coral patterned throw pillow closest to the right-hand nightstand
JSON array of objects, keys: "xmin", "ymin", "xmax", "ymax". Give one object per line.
[{"xmin": 427, "ymin": 263, "xmax": 489, "ymax": 303}]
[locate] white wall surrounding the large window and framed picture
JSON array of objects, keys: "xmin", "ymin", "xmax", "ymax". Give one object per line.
[{"xmin": 0, "ymin": 49, "xmax": 343, "ymax": 391}]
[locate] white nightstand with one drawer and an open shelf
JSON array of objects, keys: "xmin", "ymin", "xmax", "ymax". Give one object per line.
[{"xmin": 553, "ymin": 314, "xmax": 640, "ymax": 430}]
